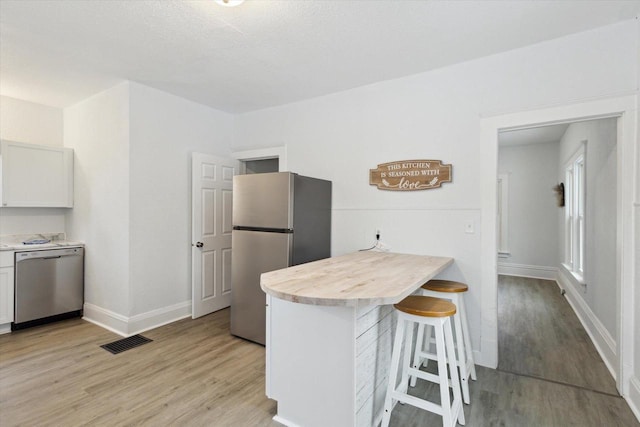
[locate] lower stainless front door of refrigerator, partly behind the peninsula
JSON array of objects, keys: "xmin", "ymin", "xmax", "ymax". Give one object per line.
[{"xmin": 231, "ymin": 230, "xmax": 293, "ymax": 345}]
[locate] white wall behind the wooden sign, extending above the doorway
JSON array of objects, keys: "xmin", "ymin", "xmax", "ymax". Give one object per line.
[{"xmin": 234, "ymin": 21, "xmax": 638, "ymax": 363}]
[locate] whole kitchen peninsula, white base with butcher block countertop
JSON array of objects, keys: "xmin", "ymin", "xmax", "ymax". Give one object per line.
[{"xmin": 261, "ymin": 251, "xmax": 453, "ymax": 427}]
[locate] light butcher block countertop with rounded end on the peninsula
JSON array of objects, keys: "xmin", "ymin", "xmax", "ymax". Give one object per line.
[{"xmin": 260, "ymin": 251, "xmax": 453, "ymax": 307}]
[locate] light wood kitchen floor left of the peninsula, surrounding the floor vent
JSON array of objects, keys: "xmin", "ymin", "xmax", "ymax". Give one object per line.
[{"xmin": 0, "ymin": 309, "xmax": 279, "ymax": 427}]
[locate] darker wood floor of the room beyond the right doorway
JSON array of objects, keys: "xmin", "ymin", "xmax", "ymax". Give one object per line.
[{"xmin": 498, "ymin": 276, "xmax": 618, "ymax": 396}]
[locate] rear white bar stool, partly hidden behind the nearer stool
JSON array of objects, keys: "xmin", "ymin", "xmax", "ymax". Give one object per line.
[{"xmin": 411, "ymin": 280, "xmax": 477, "ymax": 404}]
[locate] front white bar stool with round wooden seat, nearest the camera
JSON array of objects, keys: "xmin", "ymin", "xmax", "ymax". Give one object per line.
[{"xmin": 382, "ymin": 295, "xmax": 465, "ymax": 427}]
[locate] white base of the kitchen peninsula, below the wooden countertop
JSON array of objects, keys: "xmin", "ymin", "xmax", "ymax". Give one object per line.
[{"xmin": 266, "ymin": 296, "xmax": 395, "ymax": 427}]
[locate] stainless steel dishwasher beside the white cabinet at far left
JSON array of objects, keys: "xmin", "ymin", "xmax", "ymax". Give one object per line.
[{"xmin": 11, "ymin": 248, "xmax": 84, "ymax": 330}]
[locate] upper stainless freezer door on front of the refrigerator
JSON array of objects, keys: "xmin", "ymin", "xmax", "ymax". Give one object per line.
[{"xmin": 233, "ymin": 172, "xmax": 294, "ymax": 231}]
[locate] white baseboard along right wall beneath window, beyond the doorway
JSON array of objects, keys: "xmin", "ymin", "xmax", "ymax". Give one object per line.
[{"xmin": 557, "ymin": 271, "xmax": 618, "ymax": 379}]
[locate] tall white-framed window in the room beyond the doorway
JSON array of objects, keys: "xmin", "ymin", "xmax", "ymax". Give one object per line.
[{"xmin": 564, "ymin": 141, "xmax": 586, "ymax": 281}]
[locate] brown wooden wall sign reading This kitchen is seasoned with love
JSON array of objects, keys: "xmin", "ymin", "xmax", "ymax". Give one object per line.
[{"xmin": 369, "ymin": 160, "xmax": 451, "ymax": 191}]
